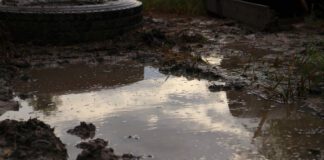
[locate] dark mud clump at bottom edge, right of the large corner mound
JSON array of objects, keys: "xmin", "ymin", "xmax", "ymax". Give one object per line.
[{"xmin": 77, "ymin": 138, "xmax": 141, "ymax": 160}]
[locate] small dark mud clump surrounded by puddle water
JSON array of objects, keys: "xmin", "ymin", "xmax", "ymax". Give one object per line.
[{"xmin": 67, "ymin": 122, "xmax": 96, "ymax": 139}]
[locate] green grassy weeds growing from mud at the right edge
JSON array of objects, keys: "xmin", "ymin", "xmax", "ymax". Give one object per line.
[{"xmin": 268, "ymin": 42, "xmax": 324, "ymax": 103}]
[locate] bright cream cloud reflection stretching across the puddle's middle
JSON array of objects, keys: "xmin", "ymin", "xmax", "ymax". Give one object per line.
[{"xmin": 5, "ymin": 67, "xmax": 249, "ymax": 139}]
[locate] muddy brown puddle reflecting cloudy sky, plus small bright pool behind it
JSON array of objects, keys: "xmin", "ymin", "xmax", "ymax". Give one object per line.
[{"xmin": 0, "ymin": 57, "xmax": 324, "ymax": 160}]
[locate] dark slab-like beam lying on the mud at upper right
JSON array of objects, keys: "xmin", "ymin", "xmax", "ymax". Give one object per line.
[{"xmin": 207, "ymin": 0, "xmax": 275, "ymax": 30}]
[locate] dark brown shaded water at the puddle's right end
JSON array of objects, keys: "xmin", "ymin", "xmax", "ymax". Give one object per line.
[{"xmin": 228, "ymin": 92, "xmax": 324, "ymax": 160}]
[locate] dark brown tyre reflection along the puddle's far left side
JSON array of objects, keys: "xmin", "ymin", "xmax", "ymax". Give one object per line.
[{"xmin": 14, "ymin": 61, "xmax": 144, "ymax": 115}]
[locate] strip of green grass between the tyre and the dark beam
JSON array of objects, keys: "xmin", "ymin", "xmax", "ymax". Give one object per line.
[{"xmin": 141, "ymin": 0, "xmax": 206, "ymax": 15}]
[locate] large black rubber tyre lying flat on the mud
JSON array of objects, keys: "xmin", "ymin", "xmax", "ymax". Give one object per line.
[{"xmin": 0, "ymin": 0, "xmax": 142, "ymax": 43}]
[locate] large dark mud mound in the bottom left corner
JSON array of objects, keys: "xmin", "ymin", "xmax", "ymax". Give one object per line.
[{"xmin": 0, "ymin": 119, "xmax": 67, "ymax": 160}]
